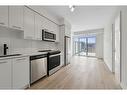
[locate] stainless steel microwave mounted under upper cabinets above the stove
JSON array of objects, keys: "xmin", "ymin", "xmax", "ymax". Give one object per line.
[{"xmin": 42, "ymin": 29, "xmax": 56, "ymax": 42}]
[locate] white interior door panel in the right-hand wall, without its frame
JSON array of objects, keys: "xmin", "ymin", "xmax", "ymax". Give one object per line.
[{"xmin": 115, "ymin": 14, "xmax": 120, "ymax": 82}]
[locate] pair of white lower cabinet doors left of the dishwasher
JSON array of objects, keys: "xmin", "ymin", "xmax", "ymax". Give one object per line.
[{"xmin": 0, "ymin": 57, "xmax": 30, "ymax": 89}]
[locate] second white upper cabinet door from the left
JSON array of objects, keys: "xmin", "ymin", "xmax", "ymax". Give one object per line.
[{"xmin": 9, "ymin": 6, "xmax": 23, "ymax": 30}]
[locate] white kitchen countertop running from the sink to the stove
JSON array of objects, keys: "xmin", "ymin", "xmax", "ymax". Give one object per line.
[{"xmin": 0, "ymin": 52, "xmax": 48, "ymax": 60}]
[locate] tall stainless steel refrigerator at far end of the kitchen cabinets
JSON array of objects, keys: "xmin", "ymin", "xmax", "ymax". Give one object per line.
[{"xmin": 64, "ymin": 36, "xmax": 71, "ymax": 65}]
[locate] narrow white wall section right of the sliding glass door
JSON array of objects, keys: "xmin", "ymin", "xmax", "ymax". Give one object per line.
[{"xmin": 96, "ymin": 33, "xmax": 104, "ymax": 59}]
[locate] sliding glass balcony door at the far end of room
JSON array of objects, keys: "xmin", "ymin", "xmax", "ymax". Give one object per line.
[{"xmin": 74, "ymin": 36, "xmax": 96, "ymax": 57}]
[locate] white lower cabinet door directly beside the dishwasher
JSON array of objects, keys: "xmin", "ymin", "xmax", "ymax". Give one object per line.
[{"xmin": 12, "ymin": 57, "xmax": 29, "ymax": 89}]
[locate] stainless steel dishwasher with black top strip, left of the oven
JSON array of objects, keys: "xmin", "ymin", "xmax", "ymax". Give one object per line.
[{"xmin": 30, "ymin": 54, "xmax": 47, "ymax": 83}]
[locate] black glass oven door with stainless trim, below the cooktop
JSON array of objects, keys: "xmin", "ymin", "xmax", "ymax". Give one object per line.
[{"xmin": 48, "ymin": 54, "xmax": 60, "ymax": 75}]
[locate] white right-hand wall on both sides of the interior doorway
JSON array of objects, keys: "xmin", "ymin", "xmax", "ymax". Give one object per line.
[{"xmin": 104, "ymin": 7, "xmax": 127, "ymax": 89}]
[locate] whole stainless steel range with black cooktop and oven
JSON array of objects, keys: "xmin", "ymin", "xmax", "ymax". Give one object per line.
[{"xmin": 39, "ymin": 50, "xmax": 61, "ymax": 75}]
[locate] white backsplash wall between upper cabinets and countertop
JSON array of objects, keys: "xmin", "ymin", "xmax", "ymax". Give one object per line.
[{"xmin": 0, "ymin": 27, "xmax": 57, "ymax": 55}]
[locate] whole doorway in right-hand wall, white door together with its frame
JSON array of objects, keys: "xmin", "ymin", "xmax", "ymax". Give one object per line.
[{"xmin": 112, "ymin": 13, "xmax": 121, "ymax": 83}]
